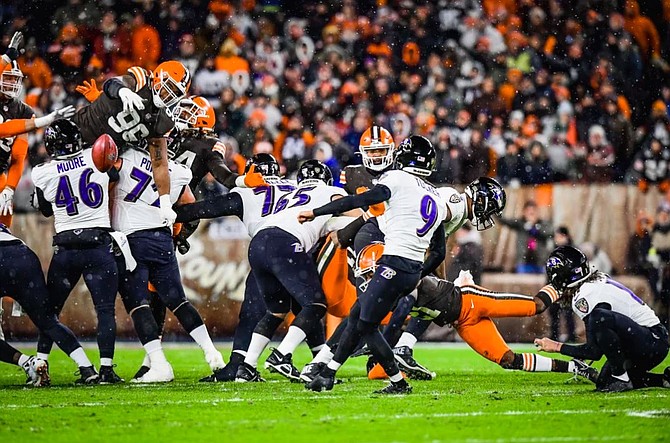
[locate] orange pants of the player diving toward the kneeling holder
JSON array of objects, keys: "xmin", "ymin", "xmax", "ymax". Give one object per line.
[{"xmin": 454, "ymin": 285, "xmax": 536, "ymax": 363}]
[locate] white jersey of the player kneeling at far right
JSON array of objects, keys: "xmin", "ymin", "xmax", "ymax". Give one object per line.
[{"xmin": 572, "ymin": 275, "xmax": 660, "ymax": 326}]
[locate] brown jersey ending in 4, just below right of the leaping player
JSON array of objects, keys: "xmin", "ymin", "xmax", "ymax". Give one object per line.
[{"xmin": 168, "ymin": 130, "xmax": 238, "ymax": 191}]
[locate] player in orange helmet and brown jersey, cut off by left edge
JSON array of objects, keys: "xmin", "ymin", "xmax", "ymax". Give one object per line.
[{"xmin": 0, "ymin": 60, "xmax": 35, "ymax": 227}]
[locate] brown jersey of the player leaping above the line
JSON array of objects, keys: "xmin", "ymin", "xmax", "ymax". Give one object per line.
[{"xmin": 72, "ymin": 67, "xmax": 174, "ymax": 149}]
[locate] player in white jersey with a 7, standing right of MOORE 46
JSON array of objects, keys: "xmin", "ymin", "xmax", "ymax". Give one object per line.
[{"xmin": 111, "ymin": 141, "xmax": 225, "ymax": 383}]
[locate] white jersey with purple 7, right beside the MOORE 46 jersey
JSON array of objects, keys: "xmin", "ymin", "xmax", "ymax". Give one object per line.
[{"xmin": 112, "ymin": 149, "xmax": 192, "ymax": 235}]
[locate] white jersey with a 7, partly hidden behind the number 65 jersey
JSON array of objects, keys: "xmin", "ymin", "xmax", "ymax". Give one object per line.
[{"xmin": 230, "ymin": 177, "xmax": 296, "ymax": 237}]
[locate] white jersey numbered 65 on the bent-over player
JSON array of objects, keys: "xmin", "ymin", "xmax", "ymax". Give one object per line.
[{"xmin": 259, "ymin": 182, "xmax": 347, "ymax": 251}]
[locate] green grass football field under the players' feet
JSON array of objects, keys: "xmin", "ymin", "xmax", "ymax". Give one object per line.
[{"xmin": 0, "ymin": 346, "xmax": 670, "ymax": 443}]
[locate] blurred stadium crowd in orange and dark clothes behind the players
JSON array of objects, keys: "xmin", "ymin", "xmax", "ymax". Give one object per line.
[{"xmin": 0, "ymin": 0, "xmax": 670, "ymax": 192}]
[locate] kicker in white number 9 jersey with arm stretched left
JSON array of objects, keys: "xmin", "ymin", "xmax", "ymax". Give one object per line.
[{"xmin": 299, "ymin": 136, "xmax": 447, "ymax": 394}]
